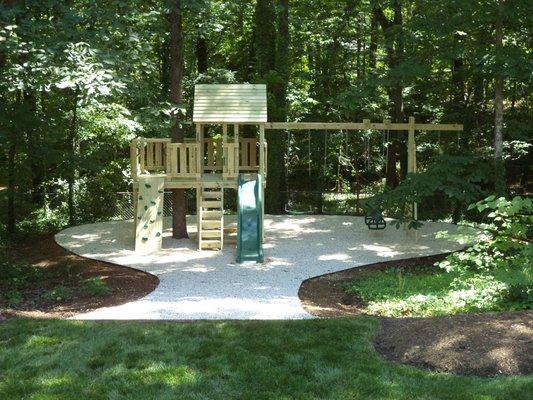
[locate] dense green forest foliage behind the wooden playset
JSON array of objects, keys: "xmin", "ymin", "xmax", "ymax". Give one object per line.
[{"xmin": 0, "ymin": 0, "xmax": 533, "ymax": 234}]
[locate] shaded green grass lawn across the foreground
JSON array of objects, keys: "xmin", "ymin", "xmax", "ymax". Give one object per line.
[{"xmin": 0, "ymin": 317, "xmax": 533, "ymax": 400}]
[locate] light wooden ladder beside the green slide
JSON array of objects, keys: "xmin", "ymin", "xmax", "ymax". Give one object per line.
[{"xmin": 198, "ymin": 188, "xmax": 224, "ymax": 250}]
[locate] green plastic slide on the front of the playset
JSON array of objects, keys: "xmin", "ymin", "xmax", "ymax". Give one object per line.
[{"xmin": 237, "ymin": 174, "xmax": 263, "ymax": 263}]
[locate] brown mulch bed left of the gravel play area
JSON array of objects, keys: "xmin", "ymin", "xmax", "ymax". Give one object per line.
[{"xmin": 0, "ymin": 235, "xmax": 159, "ymax": 321}]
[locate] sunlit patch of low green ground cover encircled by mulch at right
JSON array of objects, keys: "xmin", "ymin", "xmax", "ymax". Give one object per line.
[{"xmin": 342, "ymin": 265, "xmax": 533, "ymax": 317}]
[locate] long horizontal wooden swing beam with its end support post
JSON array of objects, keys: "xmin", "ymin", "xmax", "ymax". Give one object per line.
[{"xmin": 264, "ymin": 117, "xmax": 463, "ymax": 220}]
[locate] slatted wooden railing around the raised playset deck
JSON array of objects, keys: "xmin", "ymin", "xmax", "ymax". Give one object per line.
[{"xmin": 130, "ymin": 138, "xmax": 266, "ymax": 179}]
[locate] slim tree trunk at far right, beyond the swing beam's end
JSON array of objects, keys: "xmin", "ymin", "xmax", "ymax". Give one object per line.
[{"xmin": 494, "ymin": 0, "xmax": 505, "ymax": 195}]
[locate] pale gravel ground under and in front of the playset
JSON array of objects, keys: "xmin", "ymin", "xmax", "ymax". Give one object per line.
[{"xmin": 55, "ymin": 215, "xmax": 462, "ymax": 320}]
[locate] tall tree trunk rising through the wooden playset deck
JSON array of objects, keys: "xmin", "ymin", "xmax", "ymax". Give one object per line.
[{"xmin": 170, "ymin": 0, "xmax": 189, "ymax": 239}]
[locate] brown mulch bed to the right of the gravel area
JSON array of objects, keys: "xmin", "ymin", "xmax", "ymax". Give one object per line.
[{"xmin": 298, "ymin": 255, "xmax": 533, "ymax": 376}]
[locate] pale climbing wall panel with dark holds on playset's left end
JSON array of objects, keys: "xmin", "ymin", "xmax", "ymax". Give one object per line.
[{"xmin": 135, "ymin": 175, "xmax": 165, "ymax": 253}]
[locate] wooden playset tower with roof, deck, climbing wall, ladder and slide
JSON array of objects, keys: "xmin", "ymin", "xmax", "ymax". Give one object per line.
[{"xmin": 130, "ymin": 84, "xmax": 267, "ymax": 262}]
